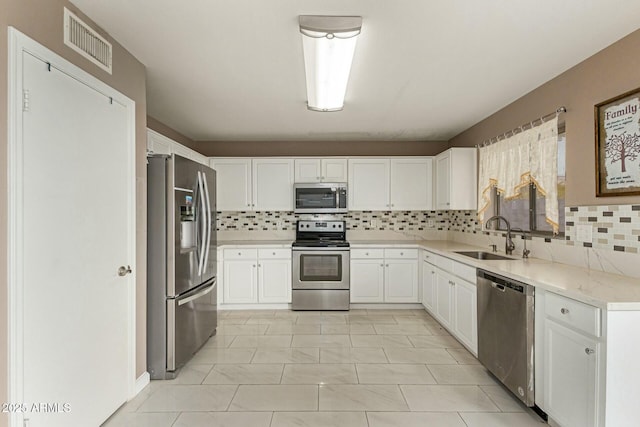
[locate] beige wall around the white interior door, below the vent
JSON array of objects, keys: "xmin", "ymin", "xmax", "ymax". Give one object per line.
[{"xmin": 0, "ymin": 0, "xmax": 147, "ymax": 426}]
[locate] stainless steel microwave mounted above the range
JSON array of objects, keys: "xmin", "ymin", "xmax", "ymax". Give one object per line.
[{"xmin": 293, "ymin": 182, "xmax": 347, "ymax": 213}]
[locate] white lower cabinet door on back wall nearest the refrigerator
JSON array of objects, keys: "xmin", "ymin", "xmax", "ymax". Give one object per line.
[{"xmin": 222, "ymin": 260, "xmax": 258, "ymax": 303}]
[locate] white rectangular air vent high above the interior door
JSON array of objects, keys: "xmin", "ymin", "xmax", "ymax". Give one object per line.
[{"xmin": 64, "ymin": 7, "xmax": 112, "ymax": 74}]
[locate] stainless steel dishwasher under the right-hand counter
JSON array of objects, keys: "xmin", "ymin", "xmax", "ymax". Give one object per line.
[{"xmin": 477, "ymin": 269, "xmax": 535, "ymax": 406}]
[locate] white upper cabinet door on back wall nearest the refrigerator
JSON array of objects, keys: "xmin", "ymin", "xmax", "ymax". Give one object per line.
[{"xmin": 211, "ymin": 159, "xmax": 253, "ymax": 211}]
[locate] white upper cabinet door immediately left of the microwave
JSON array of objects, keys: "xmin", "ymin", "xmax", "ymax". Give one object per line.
[{"xmin": 252, "ymin": 159, "xmax": 293, "ymax": 211}]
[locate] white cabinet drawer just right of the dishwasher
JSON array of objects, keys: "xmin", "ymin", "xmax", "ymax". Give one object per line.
[{"xmin": 545, "ymin": 292, "xmax": 600, "ymax": 337}]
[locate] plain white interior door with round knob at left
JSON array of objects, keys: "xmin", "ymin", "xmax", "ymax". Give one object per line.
[{"xmin": 12, "ymin": 30, "xmax": 135, "ymax": 427}]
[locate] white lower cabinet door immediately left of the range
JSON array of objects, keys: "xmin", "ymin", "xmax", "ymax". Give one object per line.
[{"xmin": 258, "ymin": 259, "xmax": 291, "ymax": 303}]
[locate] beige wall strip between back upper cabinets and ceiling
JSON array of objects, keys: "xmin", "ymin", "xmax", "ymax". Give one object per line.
[{"xmin": 196, "ymin": 141, "xmax": 448, "ymax": 157}]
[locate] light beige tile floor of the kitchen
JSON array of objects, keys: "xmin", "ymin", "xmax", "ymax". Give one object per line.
[{"xmin": 105, "ymin": 309, "xmax": 542, "ymax": 427}]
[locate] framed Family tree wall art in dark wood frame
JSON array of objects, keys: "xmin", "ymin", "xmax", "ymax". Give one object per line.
[{"xmin": 595, "ymin": 88, "xmax": 640, "ymax": 197}]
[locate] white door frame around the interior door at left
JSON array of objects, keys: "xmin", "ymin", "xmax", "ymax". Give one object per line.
[{"xmin": 7, "ymin": 27, "xmax": 138, "ymax": 426}]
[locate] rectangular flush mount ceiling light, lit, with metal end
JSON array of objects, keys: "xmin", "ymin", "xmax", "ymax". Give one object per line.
[{"xmin": 299, "ymin": 15, "xmax": 362, "ymax": 111}]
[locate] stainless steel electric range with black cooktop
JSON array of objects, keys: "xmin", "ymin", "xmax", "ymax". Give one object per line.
[{"xmin": 291, "ymin": 220, "xmax": 350, "ymax": 310}]
